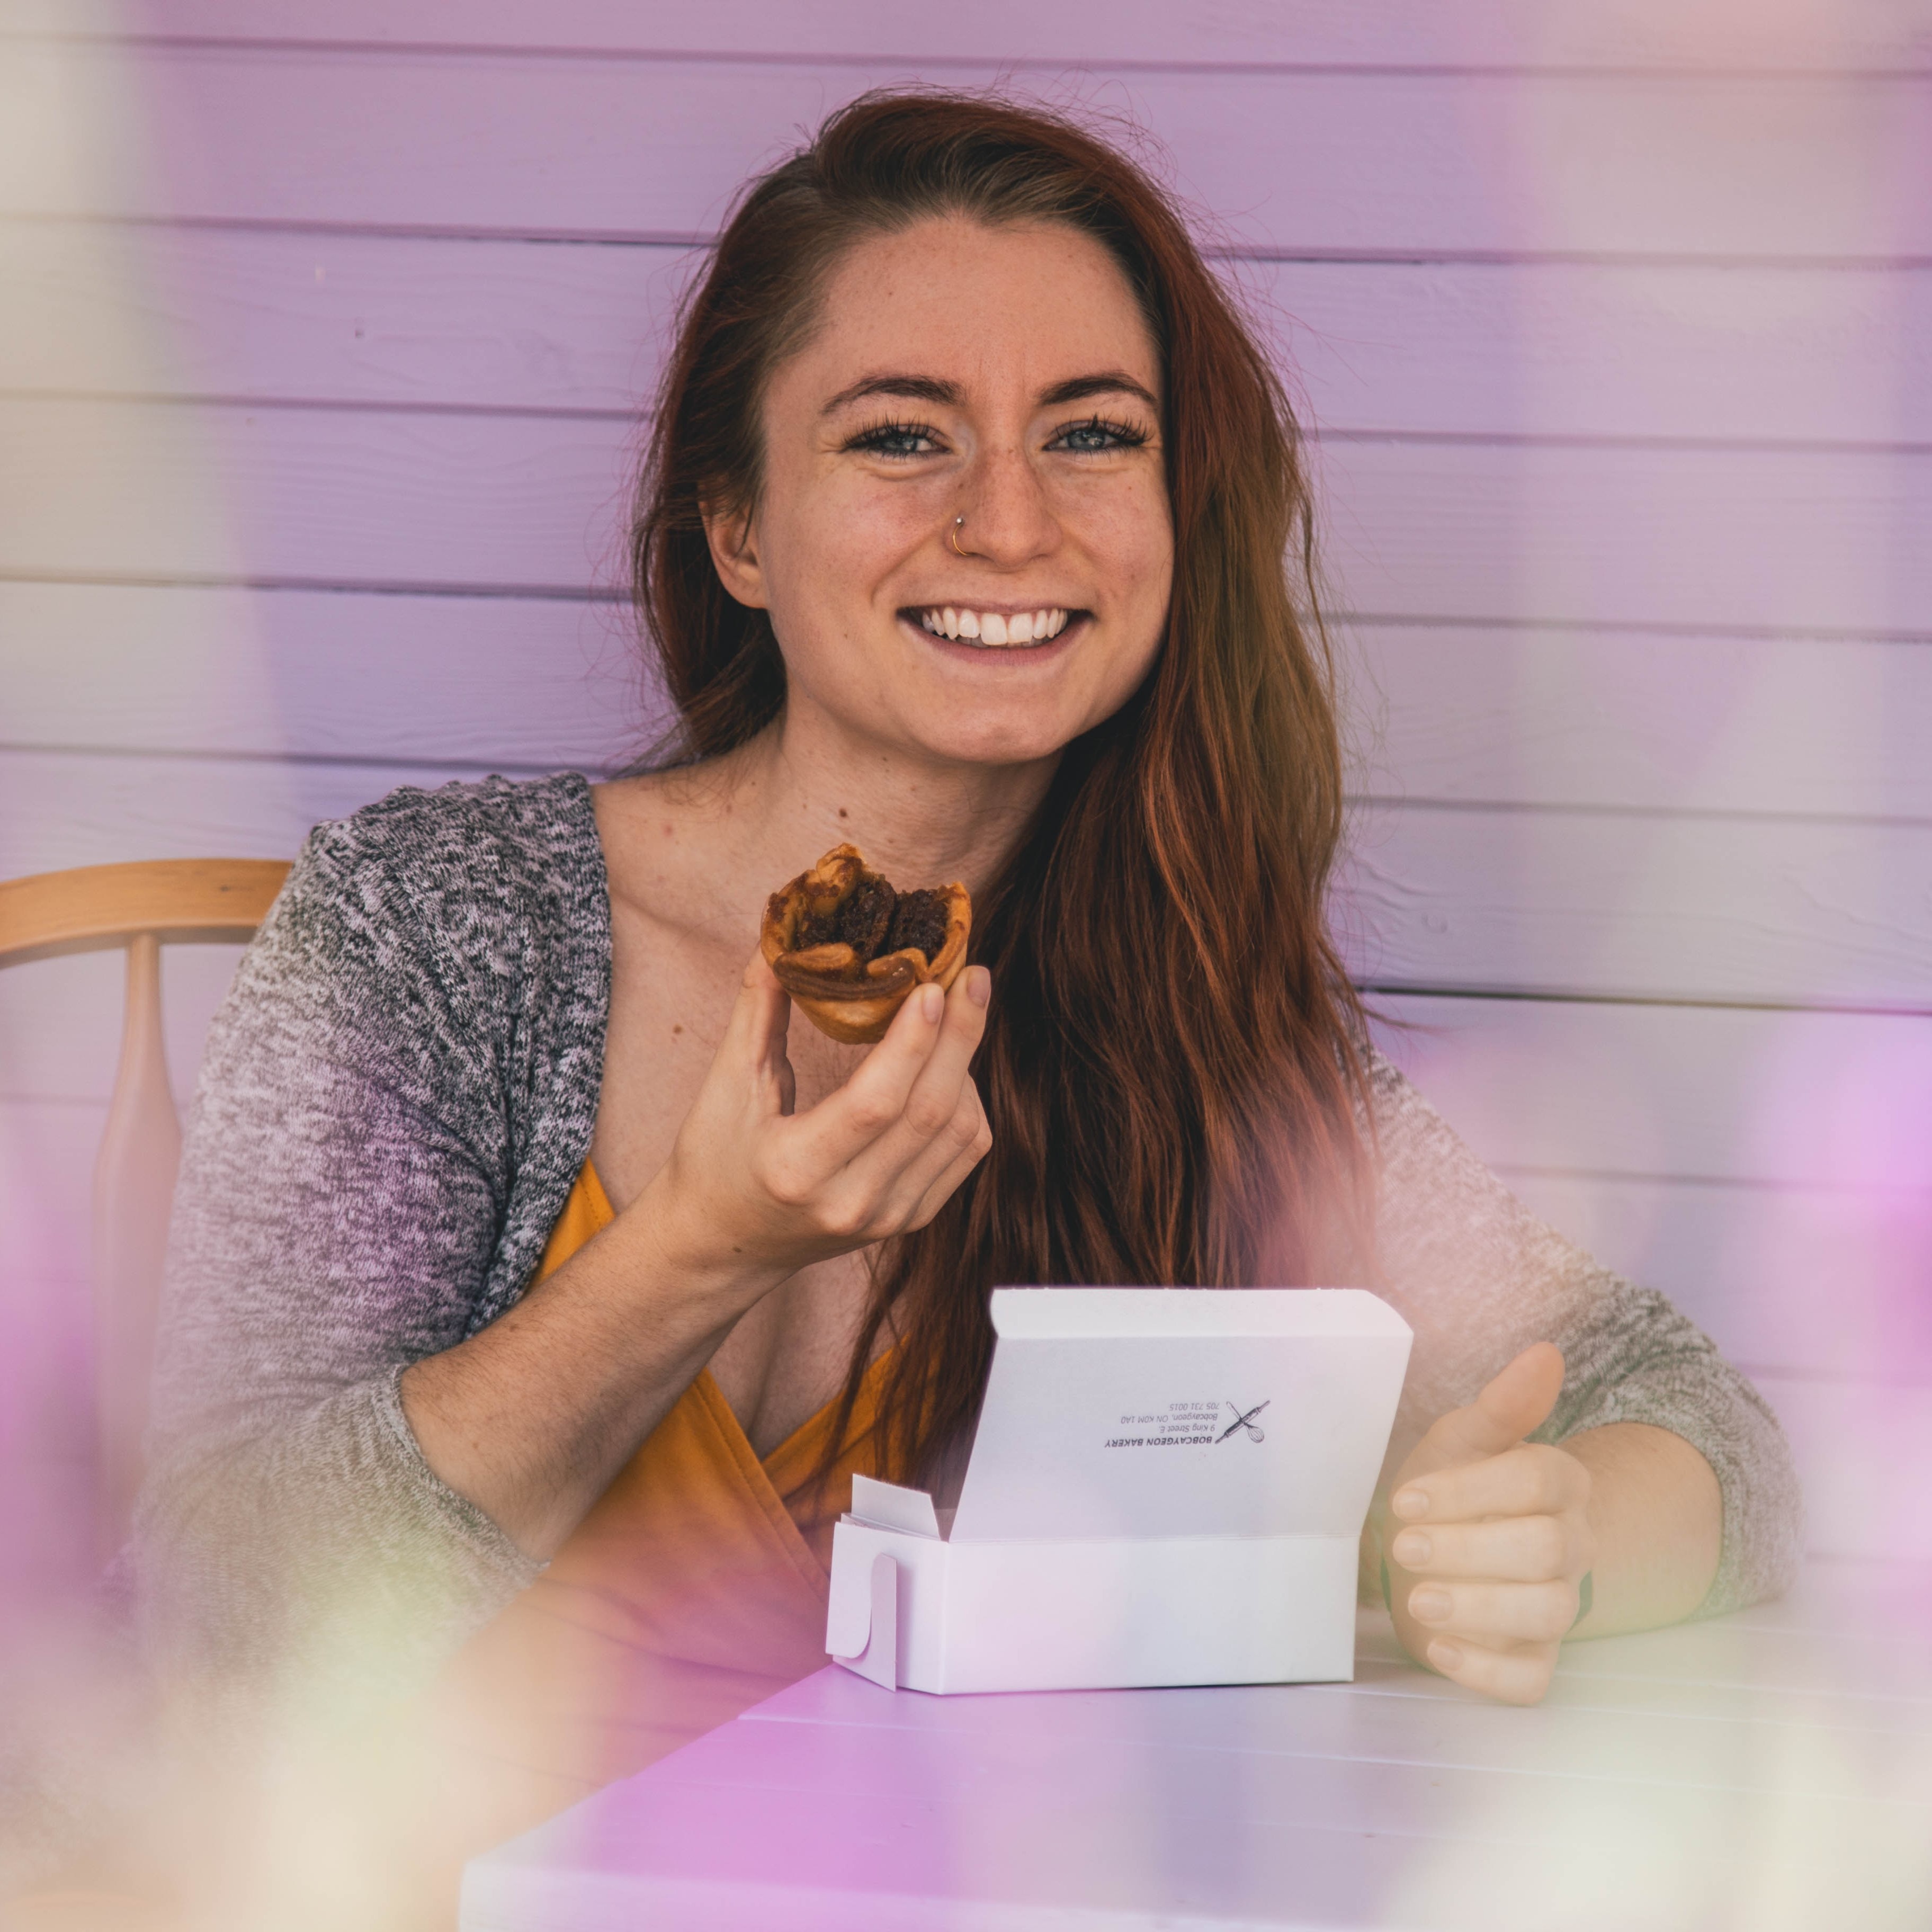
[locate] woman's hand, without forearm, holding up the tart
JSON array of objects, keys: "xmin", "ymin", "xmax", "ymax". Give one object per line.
[{"xmin": 638, "ymin": 956, "xmax": 993, "ymax": 1285}]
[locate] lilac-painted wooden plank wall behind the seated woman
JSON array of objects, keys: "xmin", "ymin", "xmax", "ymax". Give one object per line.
[{"xmin": 0, "ymin": 0, "xmax": 1932, "ymax": 1553}]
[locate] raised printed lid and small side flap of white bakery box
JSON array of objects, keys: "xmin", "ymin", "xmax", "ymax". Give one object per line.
[{"xmin": 852, "ymin": 1289, "xmax": 1410, "ymax": 1544}]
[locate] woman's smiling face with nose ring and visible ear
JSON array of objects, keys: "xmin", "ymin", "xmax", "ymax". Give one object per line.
[{"xmin": 711, "ymin": 218, "xmax": 1173, "ymax": 765}]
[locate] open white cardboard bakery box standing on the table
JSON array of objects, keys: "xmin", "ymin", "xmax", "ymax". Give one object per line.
[{"xmin": 825, "ymin": 1289, "xmax": 1410, "ymax": 1693}]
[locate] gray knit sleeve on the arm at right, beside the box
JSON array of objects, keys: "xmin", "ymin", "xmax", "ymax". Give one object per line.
[{"xmin": 1370, "ymin": 1055, "xmax": 1803, "ymax": 1617}]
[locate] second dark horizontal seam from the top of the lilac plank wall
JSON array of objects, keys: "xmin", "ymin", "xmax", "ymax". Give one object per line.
[{"xmin": 15, "ymin": 207, "xmax": 1932, "ymax": 274}]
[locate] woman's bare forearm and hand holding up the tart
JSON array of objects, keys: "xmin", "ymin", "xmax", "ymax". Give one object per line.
[{"xmin": 402, "ymin": 943, "xmax": 993, "ymax": 1561}]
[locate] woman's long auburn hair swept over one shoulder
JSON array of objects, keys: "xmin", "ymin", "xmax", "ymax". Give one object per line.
[{"xmin": 632, "ymin": 91, "xmax": 1372, "ymax": 1476}]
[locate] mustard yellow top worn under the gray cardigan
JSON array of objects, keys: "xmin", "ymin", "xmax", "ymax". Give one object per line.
[{"xmin": 423, "ymin": 1163, "xmax": 883, "ymax": 1836}]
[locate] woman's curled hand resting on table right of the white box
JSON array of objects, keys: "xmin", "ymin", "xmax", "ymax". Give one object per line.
[{"xmin": 1381, "ymin": 1343, "xmax": 1596, "ymax": 1704}]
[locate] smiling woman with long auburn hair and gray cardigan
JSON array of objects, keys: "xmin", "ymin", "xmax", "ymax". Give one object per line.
[{"xmin": 139, "ymin": 95, "xmax": 1797, "ymax": 1901}]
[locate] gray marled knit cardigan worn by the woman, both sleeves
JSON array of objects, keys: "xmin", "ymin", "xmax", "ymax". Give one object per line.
[{"xmin": 129, "ymin": 775, "xmax": 1799, "ymax": 1694}]
